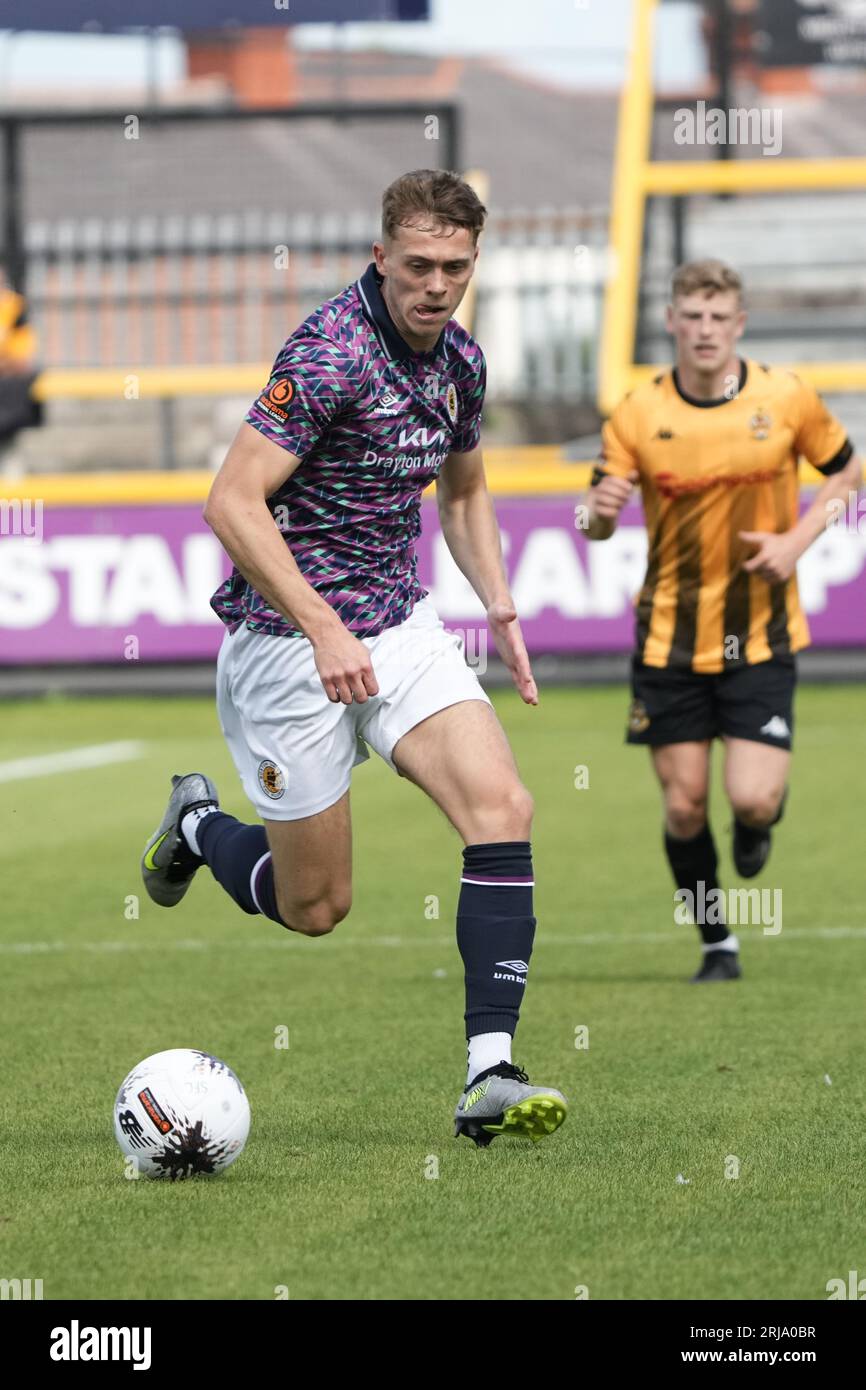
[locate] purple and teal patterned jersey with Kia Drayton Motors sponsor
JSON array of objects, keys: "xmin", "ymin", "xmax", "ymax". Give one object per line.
[{"xmin": 211, "ymin": 264, "xmax": 487, "ymax": 637}]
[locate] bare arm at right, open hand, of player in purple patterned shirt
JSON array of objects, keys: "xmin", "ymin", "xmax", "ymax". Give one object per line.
[{"xmin": 436, "ymin": 445, "xmax": 538, "ymax": 705}]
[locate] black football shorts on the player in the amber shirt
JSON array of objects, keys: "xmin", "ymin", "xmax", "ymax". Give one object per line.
[{"xmin": 626, "ymin": 656, "xmax": 796, "ymax": 749}]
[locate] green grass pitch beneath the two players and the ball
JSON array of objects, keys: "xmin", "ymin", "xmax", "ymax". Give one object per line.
[{"xmin": 0, "ymin": 685, "xmax": 866, "ymax": 1300}]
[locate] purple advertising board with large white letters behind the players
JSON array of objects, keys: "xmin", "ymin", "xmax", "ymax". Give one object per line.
[{"xmin": 0, "ymin": 496, "xmax": 866, "ymax": 664}]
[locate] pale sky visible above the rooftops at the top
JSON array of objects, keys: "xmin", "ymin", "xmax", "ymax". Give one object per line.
[{"xmin": 0, "ymin": 0, "xmax": 703, "ymax": 100}]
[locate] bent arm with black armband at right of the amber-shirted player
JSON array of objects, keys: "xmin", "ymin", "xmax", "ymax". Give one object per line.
[{"xmin": 740, "ymin": 382, "xmax": 863, "ymax": 584}]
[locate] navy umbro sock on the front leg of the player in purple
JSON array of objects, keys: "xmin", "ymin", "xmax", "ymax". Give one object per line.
[{"xmin": 457, "ymin": 840, "xmax": 535, "ymax": 1038}]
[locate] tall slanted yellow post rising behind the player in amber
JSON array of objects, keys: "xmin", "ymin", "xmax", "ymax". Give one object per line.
[{"xmin": 599, "ymin": 0, "xmax": 659, "ymax": 414}]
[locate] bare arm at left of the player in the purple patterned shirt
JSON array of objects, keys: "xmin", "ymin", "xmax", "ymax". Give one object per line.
[{"xmin": 204, "ymin": 421, "xmax": 378, "ymax": 705}]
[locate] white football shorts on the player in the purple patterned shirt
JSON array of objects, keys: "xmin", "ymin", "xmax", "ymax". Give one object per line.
[{"xmin": 217, "ymin": 598, "xmax": 491, "ymax": 820}]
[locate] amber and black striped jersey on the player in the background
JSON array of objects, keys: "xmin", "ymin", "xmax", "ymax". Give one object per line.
[{"xmin": 592, "ymin": 361, "xmax": 853, "ymax": 673}]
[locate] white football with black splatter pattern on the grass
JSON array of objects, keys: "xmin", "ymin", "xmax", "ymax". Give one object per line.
[{"xmin": 114, "ymin": 1047, "xmax": 250, "ymax": 1179}]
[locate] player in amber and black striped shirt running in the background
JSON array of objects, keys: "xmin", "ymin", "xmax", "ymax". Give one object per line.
[{"xmin": 588, "ymin": 260, "xmax": 862, "ymax": 981}]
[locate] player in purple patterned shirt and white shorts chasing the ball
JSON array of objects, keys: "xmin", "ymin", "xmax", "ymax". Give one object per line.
[{"xmin": 142, "ymin": 170, "xmax": 566, "ymax": 1145}]
